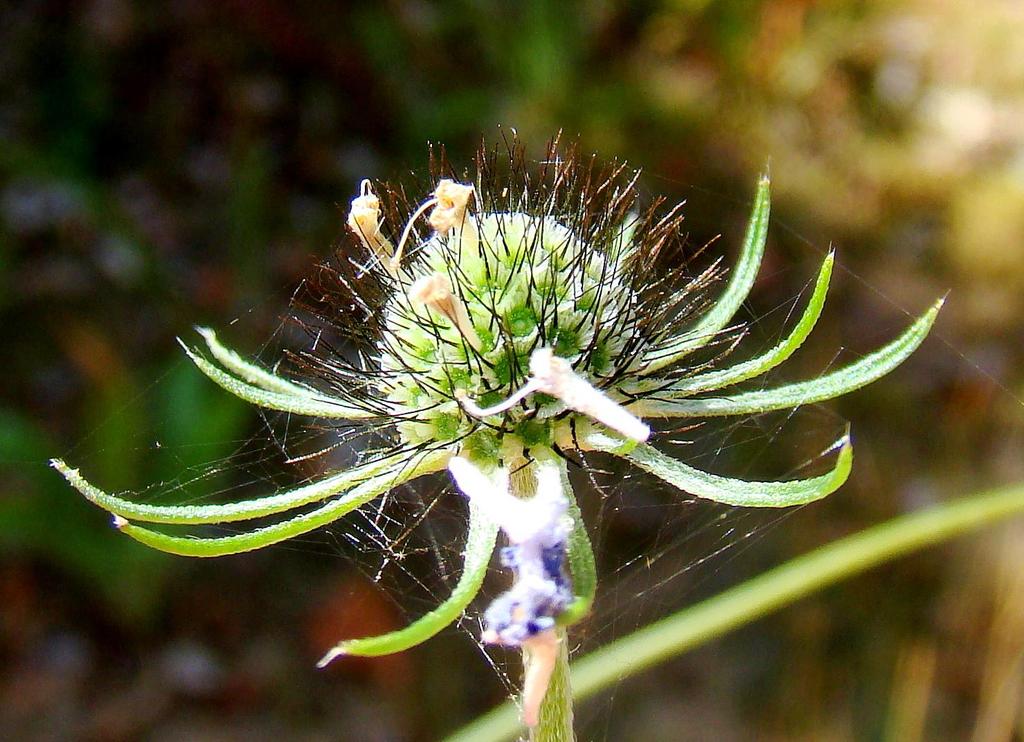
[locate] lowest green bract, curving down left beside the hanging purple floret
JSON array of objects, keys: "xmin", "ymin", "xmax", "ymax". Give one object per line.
[{"xmin": 316, "ymin": 501, "xmax": 498, "ymax": 667}]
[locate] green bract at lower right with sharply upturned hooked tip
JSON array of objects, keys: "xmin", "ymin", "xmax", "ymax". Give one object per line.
[{"xmin": 586, "ymin": 432, "xmax": 853, "ymax": 508}]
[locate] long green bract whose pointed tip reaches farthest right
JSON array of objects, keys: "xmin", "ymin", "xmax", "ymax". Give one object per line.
[{"xmin": 632, "ymin": 300, "xmax": 942, "ymax": 418}]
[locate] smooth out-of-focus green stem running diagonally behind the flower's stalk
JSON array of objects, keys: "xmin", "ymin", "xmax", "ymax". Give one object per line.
[{"xmin": 449, "ymin": 483, "xmax": 1024, "ymax": 742}]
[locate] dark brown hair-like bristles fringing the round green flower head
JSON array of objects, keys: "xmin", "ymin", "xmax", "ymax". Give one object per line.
[{"xmin": 284, "ymin": 130, "xmax": 721, "ymax": 417}]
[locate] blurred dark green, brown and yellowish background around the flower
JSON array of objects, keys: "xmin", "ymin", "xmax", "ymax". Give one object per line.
[{"xmin": 0, "ymin": 0, "xmax": 1024, "ymax": 742}]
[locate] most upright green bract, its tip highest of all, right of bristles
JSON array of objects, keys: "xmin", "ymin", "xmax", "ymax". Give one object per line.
[{"xmin": 642, "ymin": 175, "xmax": 771, "ymax": 376}]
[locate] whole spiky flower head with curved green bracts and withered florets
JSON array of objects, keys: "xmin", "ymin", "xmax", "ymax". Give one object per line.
[{"xmin": 54, "ymin": 136, "xmax": 940, "ymax": 724}]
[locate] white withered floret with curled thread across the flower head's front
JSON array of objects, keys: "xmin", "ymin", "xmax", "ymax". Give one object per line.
[{"xmin": 456, "ymin": 348, "xmax": 650, "ymax": 441}]
